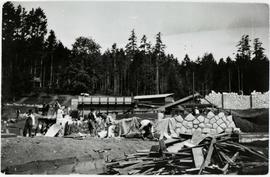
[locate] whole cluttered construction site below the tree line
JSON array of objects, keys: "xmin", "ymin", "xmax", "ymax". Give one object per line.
[{"xmin": 1, "ymin": 92, "xmax": 269, "ymax": 175}]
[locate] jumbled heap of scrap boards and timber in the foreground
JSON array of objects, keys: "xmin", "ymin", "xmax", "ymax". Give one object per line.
[{"xmin": 106, "ymin": 132, "xmax": 268, "ymax": 175}]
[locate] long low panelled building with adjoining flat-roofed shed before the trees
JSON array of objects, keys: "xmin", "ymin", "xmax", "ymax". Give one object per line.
[{"xmin": 71, "ymin": 93, "xmax": 174, "ymax": 115}]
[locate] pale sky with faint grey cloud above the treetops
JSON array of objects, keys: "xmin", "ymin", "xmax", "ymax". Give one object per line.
[{"xmin": 14, "ymin": 1, "xmax": 269, "ymax": 61}]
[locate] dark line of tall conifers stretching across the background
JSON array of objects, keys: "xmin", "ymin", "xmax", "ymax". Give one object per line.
[{"xmin": 2, "ymin": 2, "xmax": 269, "ymax": 99}]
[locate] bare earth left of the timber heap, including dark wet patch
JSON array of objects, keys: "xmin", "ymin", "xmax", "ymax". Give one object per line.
[{"xmin": 1, "ymin": 137, "xmax": 158, "ymax": 174}]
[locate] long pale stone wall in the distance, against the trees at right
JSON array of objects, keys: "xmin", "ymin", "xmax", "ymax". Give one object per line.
[{"xmin": 201, "ymin": 91, "xmax": 269, "ymax": 109}]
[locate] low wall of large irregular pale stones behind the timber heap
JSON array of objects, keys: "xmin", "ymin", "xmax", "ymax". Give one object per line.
[{"xmin": 173, "ymin": 112, "xmax": 236, "ymax": 134}]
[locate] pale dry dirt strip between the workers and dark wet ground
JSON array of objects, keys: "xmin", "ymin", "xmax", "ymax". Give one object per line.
[{"xmin": 1, "ymin": 137, "xmax": 158, "ymax": 170}]
